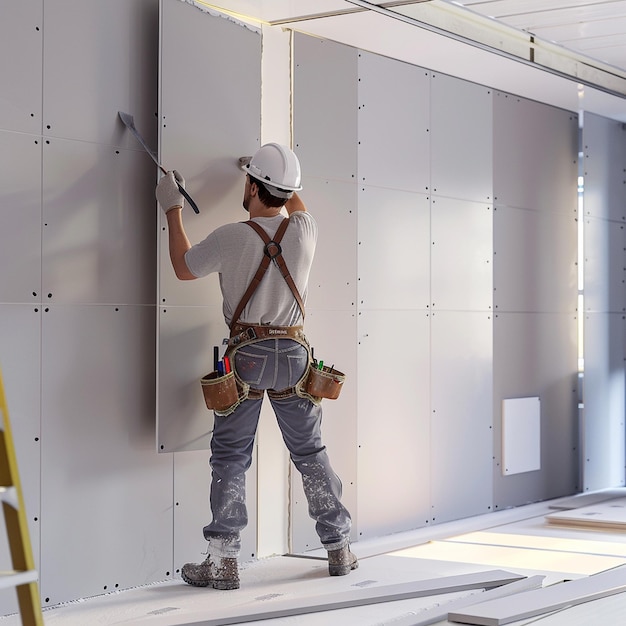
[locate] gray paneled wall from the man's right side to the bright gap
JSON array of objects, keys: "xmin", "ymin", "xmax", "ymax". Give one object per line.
[{"xmin": 294, "ymin": 35, "xmax": 578, "ymax": 549}]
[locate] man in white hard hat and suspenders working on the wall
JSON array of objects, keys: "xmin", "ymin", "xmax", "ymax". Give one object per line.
[{"xmin": 156, "ymin": 143, "xmax": 358, "ymax": 589}]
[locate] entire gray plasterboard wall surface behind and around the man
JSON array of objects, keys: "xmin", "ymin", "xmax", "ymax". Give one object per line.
[{"xmin": 0, "ymin": 0, "xmax": 625, "ymax": 615}]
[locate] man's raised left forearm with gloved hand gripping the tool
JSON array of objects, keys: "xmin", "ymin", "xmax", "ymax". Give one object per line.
[{"xmin": 156, "ymin": 172, "xmax": 197, "ymax": 280}]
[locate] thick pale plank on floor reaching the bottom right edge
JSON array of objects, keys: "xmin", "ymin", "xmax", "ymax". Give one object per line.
[{"xmin": 448, "ymin": 566, "xmax": 626, "ymax": 626}]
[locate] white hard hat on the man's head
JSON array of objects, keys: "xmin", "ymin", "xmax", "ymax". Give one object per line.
[{"xmin": 243, "ymin": 143, "xmax": 302, "ymax": 198}]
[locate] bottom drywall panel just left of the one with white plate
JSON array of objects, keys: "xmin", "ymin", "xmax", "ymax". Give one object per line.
[{"xmin": 428, "ymin": 311, "xmax": 494, "ymax": 523}]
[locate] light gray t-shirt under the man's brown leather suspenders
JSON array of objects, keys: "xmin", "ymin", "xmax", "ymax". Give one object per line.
[{"xmin": 185, "ymin": 211, "xmax": 317, "ymax": 326}]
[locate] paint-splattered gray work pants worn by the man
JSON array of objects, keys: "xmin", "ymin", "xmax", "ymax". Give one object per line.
[{"xmin": 204, "ymin": 339, "xmax": 351, "ymax": 558}]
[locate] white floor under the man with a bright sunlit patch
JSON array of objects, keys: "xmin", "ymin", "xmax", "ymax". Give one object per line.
[{"xmin": 0, "ymin": 489, "xmax": 626, "ymax": 626}]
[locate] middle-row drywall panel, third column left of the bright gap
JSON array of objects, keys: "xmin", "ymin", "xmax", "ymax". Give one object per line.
[{"xmin": 357, "ymin": 185, "xmax": 431, "ymax": 310}]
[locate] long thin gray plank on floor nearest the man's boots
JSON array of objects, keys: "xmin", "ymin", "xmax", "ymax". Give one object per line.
[{"xmin": 180, "ymin": 570, "xmax": 525, "ymax": 626}]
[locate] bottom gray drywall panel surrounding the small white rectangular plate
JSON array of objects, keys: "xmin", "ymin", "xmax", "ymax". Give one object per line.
[{"xmin": 493, "ymin": 313, "xmax": 579, "ymax": 508}]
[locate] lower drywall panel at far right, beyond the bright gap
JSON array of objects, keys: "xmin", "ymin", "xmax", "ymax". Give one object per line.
[{"xmin": 583, "ymin": 313, "xmax": 626, "ymax": 491}]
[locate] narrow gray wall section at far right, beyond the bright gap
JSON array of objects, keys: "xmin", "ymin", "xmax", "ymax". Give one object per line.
[{"xmin": 582, "ymin": 113, "xmax": 626, "ymax": 490}]
